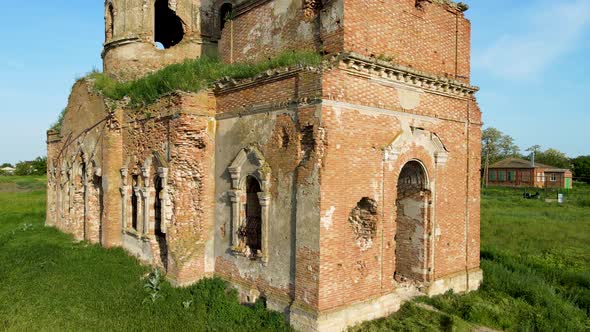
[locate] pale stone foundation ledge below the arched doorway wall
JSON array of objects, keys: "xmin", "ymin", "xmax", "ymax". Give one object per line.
[{"xmin": 289, "ymin": 269, "xmax": 483, "ymax": 332}]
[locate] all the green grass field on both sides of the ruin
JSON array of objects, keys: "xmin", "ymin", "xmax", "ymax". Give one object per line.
[{"xmin": 0, "ymin": 177, "xmax": 590, "ymax": 331}]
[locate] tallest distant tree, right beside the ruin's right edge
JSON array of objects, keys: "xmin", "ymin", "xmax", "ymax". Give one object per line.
[{"xmin": 481, "ymin": 127, "xmax": 520, "ymax": 166}]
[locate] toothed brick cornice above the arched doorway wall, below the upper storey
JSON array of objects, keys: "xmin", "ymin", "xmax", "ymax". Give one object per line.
[{"xmin": 332, "ymin": 53, "xmax": 479, "ymax": 97}]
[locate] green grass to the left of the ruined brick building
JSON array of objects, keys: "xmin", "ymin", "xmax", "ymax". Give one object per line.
[{"xmin": 0, "ymin": 177, "xmax": 289, "ymax": 331}]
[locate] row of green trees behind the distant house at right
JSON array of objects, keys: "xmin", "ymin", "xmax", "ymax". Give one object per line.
[{"xmin": 481, "ymin": 127, "xmax": 590, "ymax": 183}]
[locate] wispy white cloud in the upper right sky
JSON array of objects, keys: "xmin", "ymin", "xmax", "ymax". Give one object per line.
[{"xmin": 473, "ymin": 0, "xmax": 590, "ymax": 80}]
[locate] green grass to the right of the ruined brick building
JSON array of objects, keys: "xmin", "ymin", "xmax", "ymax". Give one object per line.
[{"xmin": 359, "ymin": 183, "xmax": 590, "ymax": 331}]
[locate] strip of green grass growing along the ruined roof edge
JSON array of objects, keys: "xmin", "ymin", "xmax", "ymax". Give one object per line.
[{"xmin": 89, "ymin": 52, "xmax": 322, "ymax": 106}]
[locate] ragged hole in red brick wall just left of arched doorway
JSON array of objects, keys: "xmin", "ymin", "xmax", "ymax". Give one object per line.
[{"xmin": 348, "ymin": 197, "xmax": 379, "ymax": 250}]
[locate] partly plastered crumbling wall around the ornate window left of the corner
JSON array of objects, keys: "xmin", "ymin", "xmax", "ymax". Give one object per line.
[{"xmin": 215, "ymin": 69, "xmax": 321, "ymax": 310}]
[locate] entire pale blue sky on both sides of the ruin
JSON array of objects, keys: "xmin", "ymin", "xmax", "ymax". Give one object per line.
[{"xmin": 0, "ymin": 0, "xmax": 590, "ymax": 162}]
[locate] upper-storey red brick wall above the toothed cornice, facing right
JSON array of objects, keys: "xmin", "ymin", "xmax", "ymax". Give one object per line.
[{"xmin": 344, "ymin": 0, "xmax": 470, "ymax": 82}]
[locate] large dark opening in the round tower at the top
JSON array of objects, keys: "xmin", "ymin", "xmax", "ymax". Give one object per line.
[{"xmin": 154, "ymin": 0, "xmax": 184, "ymax": 48}]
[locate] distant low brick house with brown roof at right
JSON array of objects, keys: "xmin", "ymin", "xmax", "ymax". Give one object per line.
[{"xmin": 487, "ymin": 158, "xmax": 573, "ymax": 189}]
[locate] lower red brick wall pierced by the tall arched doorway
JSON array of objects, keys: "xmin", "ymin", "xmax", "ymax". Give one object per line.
[{"xmin": 319, "ymin": 70, "xmax": 481, "ymax": 310}]
